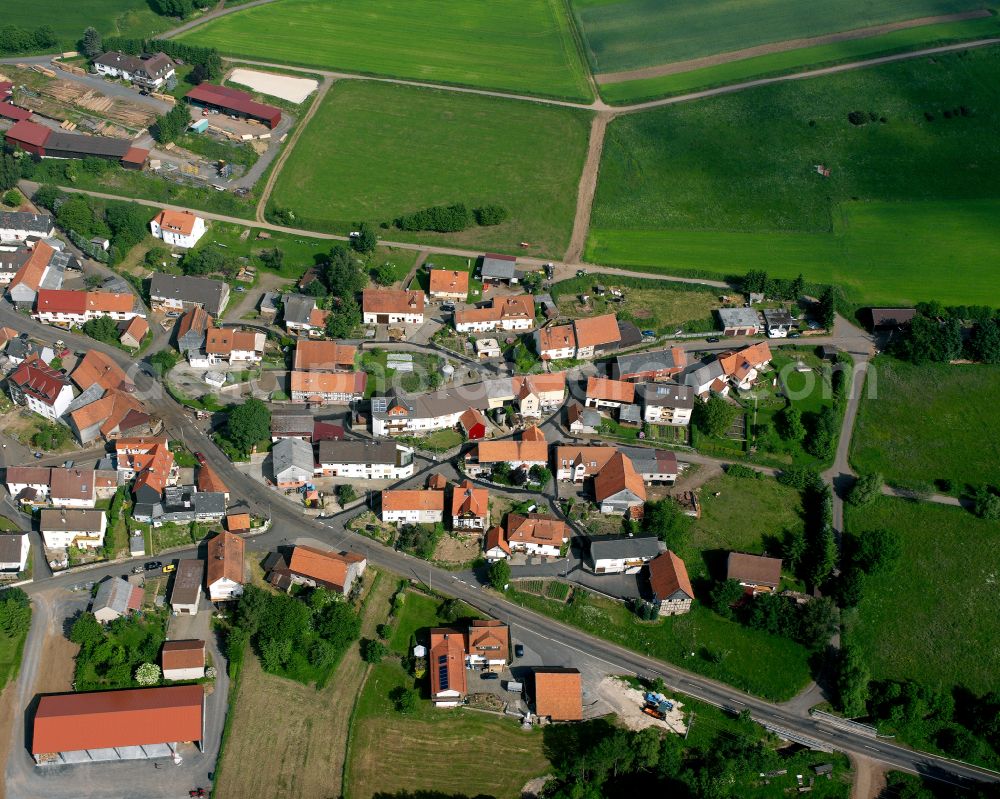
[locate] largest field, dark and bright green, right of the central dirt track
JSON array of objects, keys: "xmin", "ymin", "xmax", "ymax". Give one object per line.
[{"xmin": 587, "ymin": 47, "xmax": 1000, "ymax": 304}]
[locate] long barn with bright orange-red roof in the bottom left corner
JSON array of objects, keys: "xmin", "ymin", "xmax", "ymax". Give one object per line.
[{"xmin": 31, "ymin": 685, "xmax": 205, "ymax": 765}]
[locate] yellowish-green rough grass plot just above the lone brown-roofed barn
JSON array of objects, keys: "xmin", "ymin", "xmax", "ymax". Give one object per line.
[{"xmin": 677, "ymin": 475, "xmax": 805, "ymax": 587}]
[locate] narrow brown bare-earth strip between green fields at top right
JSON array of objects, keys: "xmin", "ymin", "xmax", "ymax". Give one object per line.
[{"xmin": 594, "ymin": 8, "xmax": 990, "ymax": 85}]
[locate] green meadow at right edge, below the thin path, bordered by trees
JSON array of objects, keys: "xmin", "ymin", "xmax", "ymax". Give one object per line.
[{"xmin": 845, "ymin": 497, "xmax": 1000, "ymax": 693}]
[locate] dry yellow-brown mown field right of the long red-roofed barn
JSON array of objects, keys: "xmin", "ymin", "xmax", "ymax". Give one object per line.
[{"xmin": 215, "ymin": 575, "xmax": 395, "ymax": 799}]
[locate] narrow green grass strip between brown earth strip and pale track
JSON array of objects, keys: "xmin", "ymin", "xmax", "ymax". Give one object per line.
[{"xmin": 598, "ymin": 16, "xmax": 1000, "ymax": 105}]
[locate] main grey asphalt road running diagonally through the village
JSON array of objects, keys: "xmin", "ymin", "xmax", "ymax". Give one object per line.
[{"xmin": 0, "ymin": 303, "xmax": 1000, "ymax": 784}]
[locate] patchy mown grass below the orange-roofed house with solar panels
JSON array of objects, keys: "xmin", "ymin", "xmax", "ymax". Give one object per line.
[{"xmin": 344, "ymin": 661, "xmax": 551, "ymax": 799}]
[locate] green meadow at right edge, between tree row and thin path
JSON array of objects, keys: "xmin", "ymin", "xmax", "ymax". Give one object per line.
[{"xmin": 851, "ymin": 356, "xmax": 1000, "ymax": 491}]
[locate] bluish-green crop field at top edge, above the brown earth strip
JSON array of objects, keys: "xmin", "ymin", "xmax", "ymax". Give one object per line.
[{"xmin": 572, "ymin": 0, "xmax": 982, "ymax": 72}]
